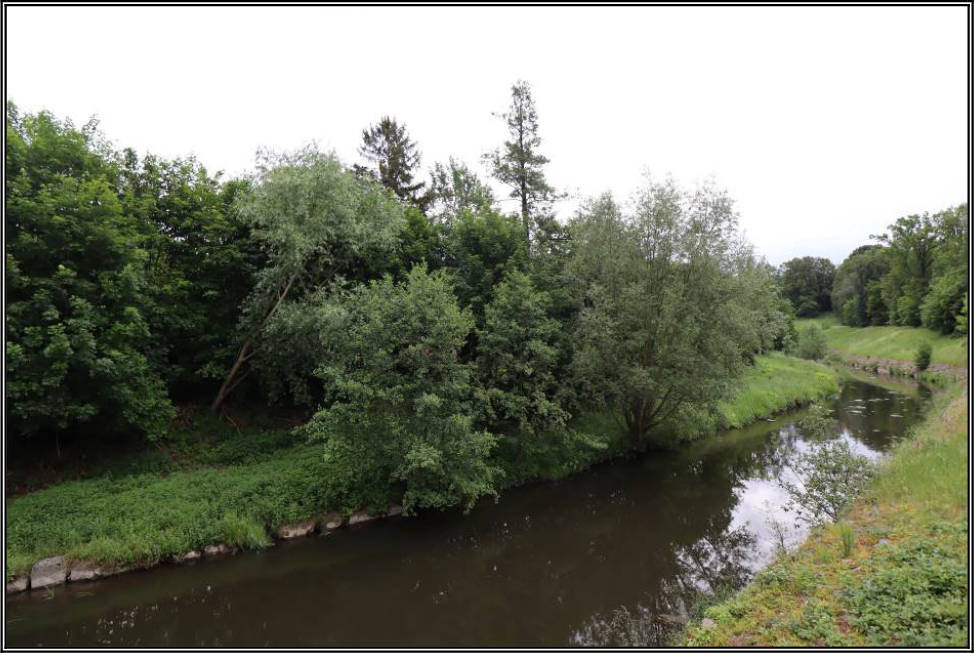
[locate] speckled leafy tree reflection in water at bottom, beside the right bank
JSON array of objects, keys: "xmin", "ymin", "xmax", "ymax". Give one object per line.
[{"xmin": 570, "ymin": 527, "xmax": 755, "ymax": 646}]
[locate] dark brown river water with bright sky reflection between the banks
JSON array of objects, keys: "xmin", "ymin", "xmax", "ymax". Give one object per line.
[{"xmin": 6, "ymin": 381, "xmax": 925, "ymax": 647}]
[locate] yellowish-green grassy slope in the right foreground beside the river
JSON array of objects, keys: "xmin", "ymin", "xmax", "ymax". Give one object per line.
[{"xmin": 683, "ymin": 386, "xmax": 968, "ymax": 646}]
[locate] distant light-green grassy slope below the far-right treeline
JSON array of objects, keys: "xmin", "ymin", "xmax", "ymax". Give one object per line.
[{"xmin": 795, "ymin": 315, "xmax": 967, "ymax": 367}]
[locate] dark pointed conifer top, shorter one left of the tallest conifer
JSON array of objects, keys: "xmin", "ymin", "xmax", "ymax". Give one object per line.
[{"xmin": 359, "ymin": 116, "xmax": 428, "ymax": 211}]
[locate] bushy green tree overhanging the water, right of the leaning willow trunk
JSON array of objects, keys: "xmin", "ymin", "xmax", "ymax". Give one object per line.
[{"xmin": 307, "ymin": 266, "xmax": 504, "ymax": 512}]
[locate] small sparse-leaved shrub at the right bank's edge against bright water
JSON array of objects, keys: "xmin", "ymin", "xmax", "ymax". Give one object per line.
[{"xmin": 781, "ymin": 440, "xmax": 873, "ymax": 524}]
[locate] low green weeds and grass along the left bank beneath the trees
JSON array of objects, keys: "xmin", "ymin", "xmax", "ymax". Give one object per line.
[{"xmin": 6, "ymin": 355, "xmax": 838, "ymax": 585}]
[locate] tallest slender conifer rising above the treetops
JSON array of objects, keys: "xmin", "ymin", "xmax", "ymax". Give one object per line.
[{"xmin": 484, "ymin": 81, "xmax": 558, "ymax": 239}]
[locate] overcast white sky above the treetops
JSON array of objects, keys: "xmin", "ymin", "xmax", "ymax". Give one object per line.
[{"xmin": 6, "ymin": 6, "xmax": 968, "ymax": 264}]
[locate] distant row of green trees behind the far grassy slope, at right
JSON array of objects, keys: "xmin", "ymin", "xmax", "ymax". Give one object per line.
[{"xmin": 779, "ymin": 204, "xmax": 970, "ymax": 335}]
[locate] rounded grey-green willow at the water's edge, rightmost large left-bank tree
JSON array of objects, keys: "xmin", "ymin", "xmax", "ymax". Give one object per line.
[{"xmin": 568, "ymin": 183, "xmax": 773, "ymax": 448}]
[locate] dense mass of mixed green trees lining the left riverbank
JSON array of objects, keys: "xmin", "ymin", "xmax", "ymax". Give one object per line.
[{"xmin": 5, "ymin": 83, "xmax": 808, "ymax": 511}]
